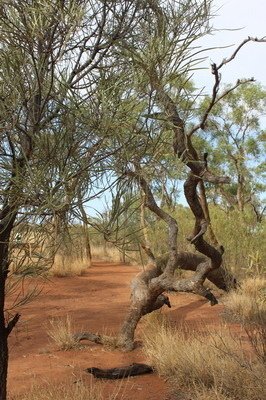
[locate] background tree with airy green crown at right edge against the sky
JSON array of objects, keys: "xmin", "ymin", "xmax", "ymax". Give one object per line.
[{"xmin": 200, "ymin": 83, "xmax": 266, "ymax": 214}]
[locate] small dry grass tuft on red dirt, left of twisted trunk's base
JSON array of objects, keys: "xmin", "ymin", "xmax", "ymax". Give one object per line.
[{"xmin": 47, "ymin": 316, "xmax": 80, "ymax": 350}]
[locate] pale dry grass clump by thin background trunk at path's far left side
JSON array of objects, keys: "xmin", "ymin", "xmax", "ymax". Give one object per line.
[{"xmin": 49, "ymin": 254, "xmax": 89, "ymax": 278}]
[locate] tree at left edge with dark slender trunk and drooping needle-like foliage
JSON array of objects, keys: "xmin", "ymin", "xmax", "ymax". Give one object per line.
[{"xmin": 0, "ymin": 0, "xmax": 154, "ymax": 400}]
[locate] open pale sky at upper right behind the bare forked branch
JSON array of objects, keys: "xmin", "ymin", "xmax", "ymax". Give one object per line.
[{"xmin": 194, "ymin": 0, "xmax": 266, "ymax": 91}]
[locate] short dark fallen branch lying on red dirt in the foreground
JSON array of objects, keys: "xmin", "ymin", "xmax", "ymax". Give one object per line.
[{"xmin": 86, "ymin": 363, "xmax": 153, "ymax": 379}]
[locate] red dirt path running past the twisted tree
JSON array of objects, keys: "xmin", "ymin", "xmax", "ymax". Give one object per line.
[{"xmin": 8, "ymin": 262, "xmax": 243, "ymax": 400}]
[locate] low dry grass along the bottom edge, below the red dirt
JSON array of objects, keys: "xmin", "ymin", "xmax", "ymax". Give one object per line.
[{"xmin": 13, "ymin": 382, "xmax": 123, "ymax": 400}]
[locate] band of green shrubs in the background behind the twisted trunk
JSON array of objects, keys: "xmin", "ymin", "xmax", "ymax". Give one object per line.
[{"xmin": 88, "ymin": 205, "xmax": 266, "ymax": 277}]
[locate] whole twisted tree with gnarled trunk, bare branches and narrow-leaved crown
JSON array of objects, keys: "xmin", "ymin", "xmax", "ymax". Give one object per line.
[{"xmin": 72, "ymin": 1, "xmax": 265, "ymax": 350}]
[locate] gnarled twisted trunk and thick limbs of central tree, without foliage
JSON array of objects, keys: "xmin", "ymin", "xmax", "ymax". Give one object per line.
[{"xmin": 73, "ymin": 85, "xmax": 235, "ymax": 350}]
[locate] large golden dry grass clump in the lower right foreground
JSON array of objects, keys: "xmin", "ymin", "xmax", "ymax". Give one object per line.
[{"xmin": 144, "ymin": 318, "xmax": 266, "ymax": 400}]
